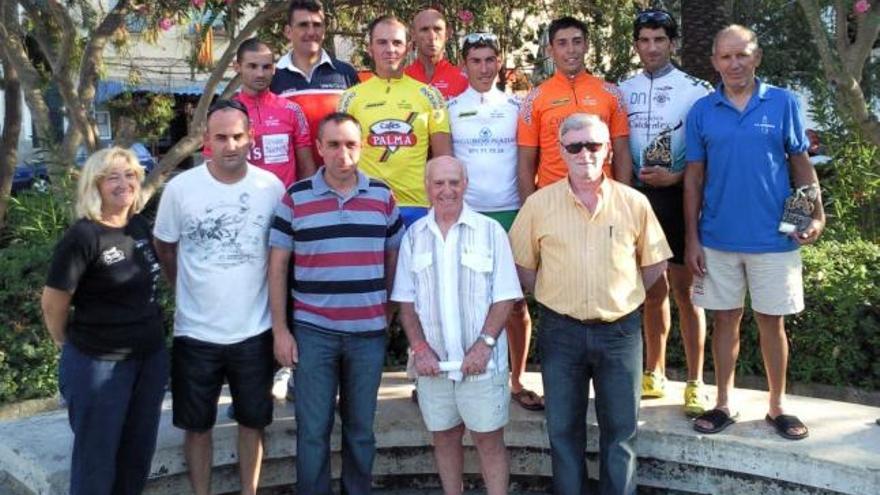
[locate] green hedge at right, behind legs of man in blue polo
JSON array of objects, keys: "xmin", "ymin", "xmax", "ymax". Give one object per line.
[{"xmin": 666, "ymin": 238, "xmax": 880, "ymax": 390}]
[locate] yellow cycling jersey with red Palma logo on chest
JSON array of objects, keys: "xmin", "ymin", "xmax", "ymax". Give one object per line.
[{"xmin": 339, "ymin": 76, "xmax": 449, "ymax": 206}]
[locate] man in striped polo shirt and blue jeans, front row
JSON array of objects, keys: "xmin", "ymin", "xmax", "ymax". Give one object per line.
[{"xmin": 269, "ymin": 113, "xmax": 403, "ymax": 495}]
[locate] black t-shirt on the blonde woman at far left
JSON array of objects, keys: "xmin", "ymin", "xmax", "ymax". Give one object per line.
[{"xmin": 46, "ymin": 215, "xmax": 164, "ymax": 360}]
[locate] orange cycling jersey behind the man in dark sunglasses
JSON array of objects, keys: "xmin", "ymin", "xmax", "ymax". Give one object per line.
[{"xmin": 516, "ymin": 72, "xmax": 629, "ymax": 187}]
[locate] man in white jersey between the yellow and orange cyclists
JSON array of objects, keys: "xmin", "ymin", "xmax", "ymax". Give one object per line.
[{"xmin": 448, "ymin": 33, "xmax": 544, "ymax": 411}]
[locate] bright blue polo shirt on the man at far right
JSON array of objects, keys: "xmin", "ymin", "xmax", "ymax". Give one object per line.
[{"xmin": 686, "ymin": 79, "xmax": 809, "ymax": 253}]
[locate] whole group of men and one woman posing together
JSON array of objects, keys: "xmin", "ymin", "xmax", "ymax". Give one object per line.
[{"xmin": 42, "ymin": 0, "xmax": 824, "ymax": 495}]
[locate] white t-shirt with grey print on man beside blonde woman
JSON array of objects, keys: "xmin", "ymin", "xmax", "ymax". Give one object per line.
[{"xmin": 153, "ymin": 165, "xmax": 284, "ymax": 345}]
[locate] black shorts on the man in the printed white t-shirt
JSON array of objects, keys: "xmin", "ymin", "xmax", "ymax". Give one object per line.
[{"xmin": 171, "ymin": 330, "xmax": 275, "ymax": 432}]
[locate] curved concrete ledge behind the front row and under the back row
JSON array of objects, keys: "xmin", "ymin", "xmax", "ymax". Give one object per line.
[{"xmin": 0, "ymin": 373, "xmax": 880, "ymax": 495}]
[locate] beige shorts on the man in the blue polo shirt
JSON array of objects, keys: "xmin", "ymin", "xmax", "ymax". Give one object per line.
[{"xmin": 693, "ymin": 247, "xmax": 804, "ymax": 315}]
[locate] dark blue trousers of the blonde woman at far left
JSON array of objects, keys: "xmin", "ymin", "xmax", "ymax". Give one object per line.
[{"xmin": 58, "ymin": 343, "xmax": 168, "ymax": 495}]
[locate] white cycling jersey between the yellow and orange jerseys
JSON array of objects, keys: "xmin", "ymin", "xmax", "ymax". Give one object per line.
[{"xmin": 447, "ymin": 87, "xmax": 519, "ymax": 211}]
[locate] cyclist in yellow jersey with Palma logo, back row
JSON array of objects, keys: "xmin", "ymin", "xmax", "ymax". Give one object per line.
[{"xmin": 339, "ymin": 16, "xmax": 452, "ymax": 226}]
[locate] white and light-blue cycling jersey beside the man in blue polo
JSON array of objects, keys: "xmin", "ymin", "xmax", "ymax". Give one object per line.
[{"xmin": 619, "ymin": 64, "xmax": 712, "ymax": 181}]
